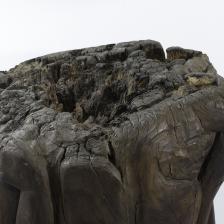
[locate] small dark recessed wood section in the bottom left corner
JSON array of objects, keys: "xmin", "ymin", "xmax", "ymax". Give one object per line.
[{"xmin": 0, "ymin": 180, "xmax": 20, "ymax": 224}]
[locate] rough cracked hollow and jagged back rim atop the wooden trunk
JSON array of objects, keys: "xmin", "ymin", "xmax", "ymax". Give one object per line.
[{"xmin": 0, "ymin": 40, "xmax": 222, "ymax": 124}]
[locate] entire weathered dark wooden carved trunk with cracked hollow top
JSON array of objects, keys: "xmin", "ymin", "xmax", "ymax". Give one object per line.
[{"xmin": 0, "ymin": 40, "xmax": 224, "ymax": 224}]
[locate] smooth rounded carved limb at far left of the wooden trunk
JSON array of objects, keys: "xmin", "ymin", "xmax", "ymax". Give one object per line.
[{"xmin": 0, "ymin": 149, "xmax": 54, "ymax": 224}]
